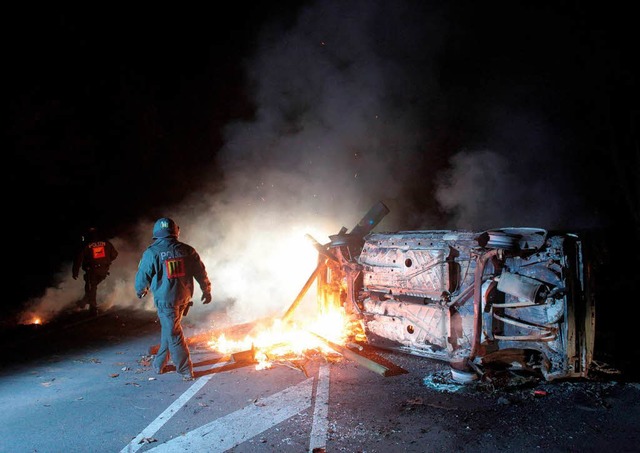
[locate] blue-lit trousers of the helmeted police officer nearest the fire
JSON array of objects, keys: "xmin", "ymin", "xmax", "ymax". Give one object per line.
[{"xmin": 153, "ymin": 306, "xmax": 193, "ymax": 375}]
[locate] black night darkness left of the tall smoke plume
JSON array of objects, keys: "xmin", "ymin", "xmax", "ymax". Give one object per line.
[{"xmin": 4, "ymin": 2, "xmax": 297, "ymax": 304}]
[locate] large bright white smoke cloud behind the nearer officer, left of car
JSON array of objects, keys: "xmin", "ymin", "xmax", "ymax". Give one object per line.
[{"xmin": 23, "ymin": 1, "xmax": 444, "ymax": 322}]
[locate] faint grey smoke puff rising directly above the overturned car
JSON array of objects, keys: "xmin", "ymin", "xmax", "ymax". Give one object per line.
[{"xmin": 435, "ymin": 109, "xmax": 598, "ymax": 231}]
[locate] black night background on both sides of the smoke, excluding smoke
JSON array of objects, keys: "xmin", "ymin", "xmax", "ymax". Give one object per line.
[{"xmin": 3, "ymin": 1, "xmax": 640, "ymax": 364}]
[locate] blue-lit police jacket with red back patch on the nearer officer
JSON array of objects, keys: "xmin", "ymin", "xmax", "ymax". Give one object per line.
[{"xmin": 135, "ymin": 237, "xmax": 211, "ymax": 307}]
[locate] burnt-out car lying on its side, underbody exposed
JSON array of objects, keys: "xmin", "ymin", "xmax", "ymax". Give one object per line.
[{"xmin": 318, "ymin": 203, "xmax": 595, "ymax": 381}]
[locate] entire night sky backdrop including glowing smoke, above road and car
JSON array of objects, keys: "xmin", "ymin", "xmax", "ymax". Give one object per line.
[{"xmin": 4, "ymin": 1, "xmax": 640, "ymax": 319}]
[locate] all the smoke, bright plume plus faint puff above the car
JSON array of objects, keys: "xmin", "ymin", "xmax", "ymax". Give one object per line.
[{"xmin": 20, "ymin": 0, "xmax": 600, "ymax": 327}]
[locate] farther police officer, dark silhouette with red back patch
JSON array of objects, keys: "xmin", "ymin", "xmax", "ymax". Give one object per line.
[{"xmin": 71, "ymin": 227, "xmax": 118, "ymax": 316}]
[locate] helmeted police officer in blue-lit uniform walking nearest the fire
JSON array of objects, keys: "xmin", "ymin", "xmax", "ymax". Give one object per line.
[{"xmin": 135, "ymin": 217, "xmax": 211, "ymax": 380}]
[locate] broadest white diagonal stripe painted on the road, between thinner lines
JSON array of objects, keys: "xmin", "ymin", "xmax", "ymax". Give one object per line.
[{"xmin": 148, "ymin": 378, "xmax": 313, "ymax": 453}]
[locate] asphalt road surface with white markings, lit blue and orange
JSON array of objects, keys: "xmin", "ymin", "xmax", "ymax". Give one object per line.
[{"xmin": 0, "ymin": 309, "xmax": 640, "ymax": 453}]
